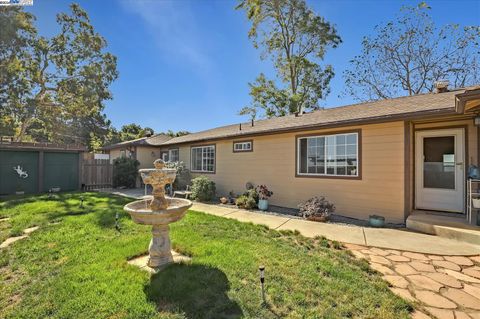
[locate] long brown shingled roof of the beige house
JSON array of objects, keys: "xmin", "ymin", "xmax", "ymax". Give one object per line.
[{"xmin": 163, "ymin": 86, "xmax": 480, "ymax": 145}]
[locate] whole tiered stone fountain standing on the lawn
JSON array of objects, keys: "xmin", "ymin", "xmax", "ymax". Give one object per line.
[{"xmin": 124, "ymin": 159, "xmax": 192, "ymax": 268}]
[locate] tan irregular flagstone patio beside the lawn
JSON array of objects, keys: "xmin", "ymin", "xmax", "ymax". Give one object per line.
[{"xmin": 345, "ymin": 244, "xmax": 480, "ymax": 319}]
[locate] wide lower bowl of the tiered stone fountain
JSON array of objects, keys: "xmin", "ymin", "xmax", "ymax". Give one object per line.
[{"xmin": 124, "ymin": 198, "xmax": 192, "ymax": 225}]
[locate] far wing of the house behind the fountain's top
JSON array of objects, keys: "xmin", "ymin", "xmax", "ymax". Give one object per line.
[{"xmin": 102, "ymin": 134, "xmax": 175, "ymax": 168}]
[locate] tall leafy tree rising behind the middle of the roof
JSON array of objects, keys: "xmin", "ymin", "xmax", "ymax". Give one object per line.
[{"xmin": 237, "ymin": 0, "xmax": 341, "ymax": 117}]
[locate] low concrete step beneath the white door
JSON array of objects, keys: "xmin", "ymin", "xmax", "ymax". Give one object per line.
[{"xmin": 406, "ymin": 213, "xmax": 480, "ymax": 245}]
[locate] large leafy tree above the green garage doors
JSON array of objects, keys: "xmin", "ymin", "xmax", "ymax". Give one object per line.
[{"xmin": 0, "ymin": 4, "xmax": 118, "ymax": 143}]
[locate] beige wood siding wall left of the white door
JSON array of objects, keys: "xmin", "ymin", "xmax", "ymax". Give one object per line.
[{"xmin": 179, "ymin": 121, "xmax": 405, "ymax": 222}]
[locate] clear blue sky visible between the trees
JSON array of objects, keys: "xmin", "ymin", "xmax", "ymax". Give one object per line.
[{"xmin": 29, "ymin": 0, "xmax": 480, "ymax": 132}]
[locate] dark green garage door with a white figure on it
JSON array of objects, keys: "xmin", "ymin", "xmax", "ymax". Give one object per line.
[{"xmin": 0, "ymin": 151, "xmax": 38, "ymax": 194}]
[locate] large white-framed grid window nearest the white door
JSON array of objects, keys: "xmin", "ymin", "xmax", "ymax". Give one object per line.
[{"xmin": 297, "ymin": 132, "xmax": 360, "ymax": 177}]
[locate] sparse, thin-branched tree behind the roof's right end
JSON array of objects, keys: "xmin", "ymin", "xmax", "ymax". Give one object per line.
[{"xmin": 344, "ymin": 2, "xmax": 480, "ymax": 101}]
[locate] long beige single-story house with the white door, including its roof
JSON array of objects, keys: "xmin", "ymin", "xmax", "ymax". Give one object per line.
[{"xmin": 157, "ymin": 86, "xmax": 480, "ymax": 223}]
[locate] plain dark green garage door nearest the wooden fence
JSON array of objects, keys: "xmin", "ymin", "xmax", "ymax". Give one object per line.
[{"xmin": 43, "ymin": 152, "xmax": 78, "ymax": 192}]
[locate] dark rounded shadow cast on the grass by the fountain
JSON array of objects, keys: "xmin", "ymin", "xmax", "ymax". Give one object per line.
[{"xmin": 144, "ymin": 264, "xmax": 243, "ymax": 318}]
